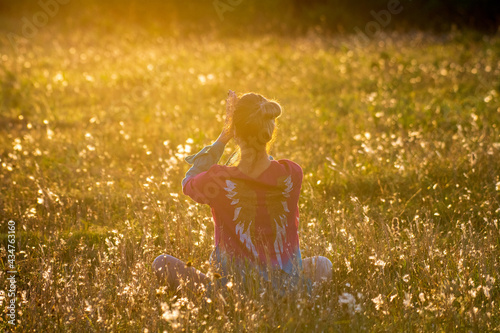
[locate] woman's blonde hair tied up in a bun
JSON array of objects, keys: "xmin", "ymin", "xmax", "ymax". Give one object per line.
[{"xmin": 232, "ymin": 93, "xmax": 281, "ymax": 148}]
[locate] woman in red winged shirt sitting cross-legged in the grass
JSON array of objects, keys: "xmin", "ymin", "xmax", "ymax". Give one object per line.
[{"xmin": 153, "ymin": 91, "xmax": 332, "ymax": 289}]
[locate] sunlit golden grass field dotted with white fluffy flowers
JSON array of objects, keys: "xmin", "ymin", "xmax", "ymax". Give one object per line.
[{"xmin": 0, "ymin": 3, "xmax": 500, "ymax": 332}]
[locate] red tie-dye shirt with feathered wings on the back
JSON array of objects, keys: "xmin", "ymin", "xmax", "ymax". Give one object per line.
[{"xmin": 182, "ymin": 143, "xmax": 303, "ymax": 276}]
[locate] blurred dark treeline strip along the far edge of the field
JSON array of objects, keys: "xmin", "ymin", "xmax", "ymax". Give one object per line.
[{"xmin": 0, "ymin": 0, "xmax": 500, "ymax": 34}]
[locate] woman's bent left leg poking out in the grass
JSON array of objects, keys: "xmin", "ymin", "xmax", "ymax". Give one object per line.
[{"xmin": 152, "ymin": 254, "xmax": 209, "ymax": 290}]
